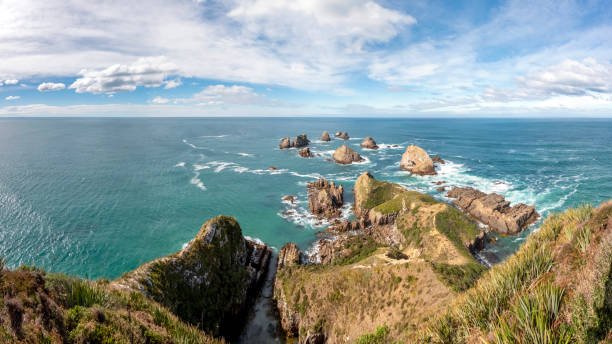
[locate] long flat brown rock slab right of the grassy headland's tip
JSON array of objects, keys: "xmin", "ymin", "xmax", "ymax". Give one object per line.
[{"xmin": 446, "ymin": 187, "xmax": 540, "ymax": 234}]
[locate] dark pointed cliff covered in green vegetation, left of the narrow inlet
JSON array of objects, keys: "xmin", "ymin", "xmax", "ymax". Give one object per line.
[{"xmin": 115, "ymin": 216, "xmax": 270, "ymax": 334}]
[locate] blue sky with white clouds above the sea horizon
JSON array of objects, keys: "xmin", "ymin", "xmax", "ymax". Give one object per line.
[{"xmin": 0, "ymin": 0, "xmax": 612, "ymax": 117}]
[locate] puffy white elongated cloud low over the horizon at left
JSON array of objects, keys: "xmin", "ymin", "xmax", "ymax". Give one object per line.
[{"xmin": 70, "ymin": 56, "xmax": 178, "ymax": 94}]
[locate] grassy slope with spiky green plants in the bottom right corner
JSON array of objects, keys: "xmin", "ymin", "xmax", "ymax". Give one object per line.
[{"xmin": 421, "ymin": 202, "xmax": 612, "ymax": 344}]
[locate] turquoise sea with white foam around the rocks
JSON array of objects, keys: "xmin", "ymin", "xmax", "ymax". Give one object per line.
[{"xmin": 0, "ymin": 118, "xmax": 612, "ymax": 278}]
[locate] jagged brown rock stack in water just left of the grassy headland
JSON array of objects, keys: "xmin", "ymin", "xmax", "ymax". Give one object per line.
[{"xmin": 307, "ymin": 178, "xmax": 344, "ymax": 218}]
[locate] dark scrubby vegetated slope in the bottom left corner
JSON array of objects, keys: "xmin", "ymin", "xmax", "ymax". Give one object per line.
[{"xmin": 0, "ymin": 266, "xmax": 223, "ymax": 344}]
